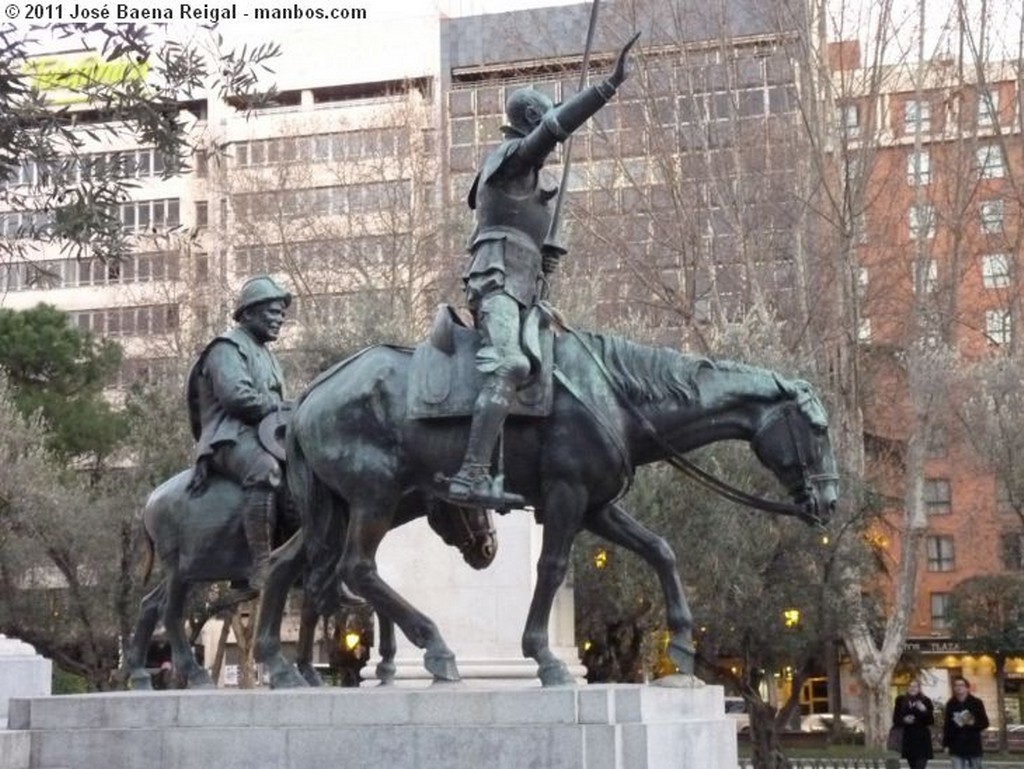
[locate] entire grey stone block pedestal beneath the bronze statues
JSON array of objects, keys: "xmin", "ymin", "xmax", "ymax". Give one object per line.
[{"xmin": 10, "ymin": 685, "xmax": 737, "ymax": 769}]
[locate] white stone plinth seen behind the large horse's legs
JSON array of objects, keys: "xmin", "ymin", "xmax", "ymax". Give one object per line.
[{"xmin": 376, "ymin": 511, "xmax": 586, "ymax": 683}]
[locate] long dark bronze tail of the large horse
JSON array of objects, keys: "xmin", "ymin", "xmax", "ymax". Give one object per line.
[{"xmin": 287, "ymin": 430, "xmax": 348, "ymax": 613}]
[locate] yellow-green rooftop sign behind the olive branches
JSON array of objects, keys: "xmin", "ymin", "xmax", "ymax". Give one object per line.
[{"xmin": 23, "ymin": 51, "xmax": 148, "ymax": 104}]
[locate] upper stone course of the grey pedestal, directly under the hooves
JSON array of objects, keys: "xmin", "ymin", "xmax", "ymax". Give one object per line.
[{"xmin": 9, "ymin": 685, "xmax": 724, "ymax": 730}]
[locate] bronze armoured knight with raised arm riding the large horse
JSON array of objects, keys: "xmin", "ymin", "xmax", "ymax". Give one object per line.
[{"xmin": 123, "ymin": 22, "xmax": 838, "ymax": 686}]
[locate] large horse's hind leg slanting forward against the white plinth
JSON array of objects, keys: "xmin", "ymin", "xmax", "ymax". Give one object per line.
[{"xmin": 341, "ymin": 501, "xmax": 460, "ymax": 681}]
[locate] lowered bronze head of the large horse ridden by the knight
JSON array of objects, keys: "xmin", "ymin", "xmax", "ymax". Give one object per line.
[{"xmin": 751, "ymin": 377, "xmax": 839, "ymax": 523}]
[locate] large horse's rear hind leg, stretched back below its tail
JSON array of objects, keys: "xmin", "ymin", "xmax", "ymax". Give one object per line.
[{"xmin": 255, "ymin": 529, "xmax": 308, "ymax": 689}]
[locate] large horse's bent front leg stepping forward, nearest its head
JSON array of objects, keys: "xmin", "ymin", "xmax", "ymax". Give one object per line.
[{"xmin": 584, "ymin": 505, "xmax": 695, "ymax": 675}]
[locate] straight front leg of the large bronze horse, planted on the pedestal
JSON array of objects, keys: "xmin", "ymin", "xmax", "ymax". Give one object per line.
[{"xmin": 522, "ymin": 481, "xmax": 586, "ymax": 686}]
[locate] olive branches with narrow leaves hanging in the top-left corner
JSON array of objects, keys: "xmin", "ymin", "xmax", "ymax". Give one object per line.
[{"xmin": 0, "ymin": 24, "xmax": 279, "ymax": 270}]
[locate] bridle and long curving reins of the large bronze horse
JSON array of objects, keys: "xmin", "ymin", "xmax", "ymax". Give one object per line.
[{"xmin": 563, "ymin": 325, "xmax": 839, "ymax": 523}]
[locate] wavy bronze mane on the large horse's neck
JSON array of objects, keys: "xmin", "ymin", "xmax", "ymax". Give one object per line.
[{"xmin": 575, "ymin": 331, "xmax": 714, "ymax": 403}]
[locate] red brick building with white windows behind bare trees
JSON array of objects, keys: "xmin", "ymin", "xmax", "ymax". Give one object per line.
[{"xmin": 830, "ymin": 43, "xmax": 1024, "ymax": 723}]
